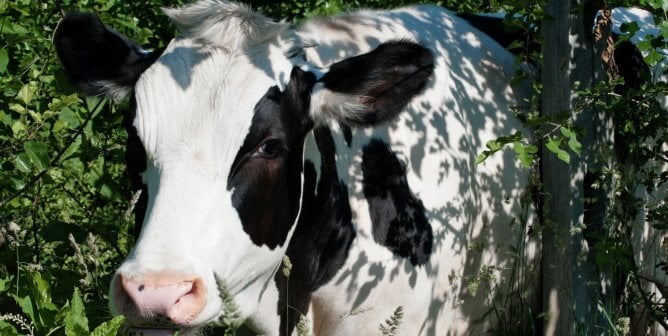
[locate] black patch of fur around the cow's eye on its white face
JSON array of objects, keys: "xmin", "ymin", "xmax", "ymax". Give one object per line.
[{"xmin": 227, "ymin": 67, "xmax": 315, "ymax": 249}]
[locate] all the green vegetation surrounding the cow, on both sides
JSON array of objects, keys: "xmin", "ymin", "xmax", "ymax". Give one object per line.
[{"xmin": 0, "ymin": 0, "xmax": 668, "ymax": 335}]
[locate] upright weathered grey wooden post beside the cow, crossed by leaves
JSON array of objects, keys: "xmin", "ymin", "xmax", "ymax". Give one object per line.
[{"xmin": 541, "ymin": 0, "xmax": 575, "ymax": 336}]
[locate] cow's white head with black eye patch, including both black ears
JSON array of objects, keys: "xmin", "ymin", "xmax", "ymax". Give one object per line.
[{"xmin": 55, "ymin": 1, "xmax": 433, "ymax": 330}]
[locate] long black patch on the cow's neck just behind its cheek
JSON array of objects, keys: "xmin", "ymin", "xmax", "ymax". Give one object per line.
[{"xmin": 275, "ymin": 127, "xmax": 355, "ymax": 335}]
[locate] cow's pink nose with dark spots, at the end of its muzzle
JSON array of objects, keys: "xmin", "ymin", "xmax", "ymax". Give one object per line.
[{"xmin": 114, "ymin": 273, "xmax": 206, "ymax": 325}]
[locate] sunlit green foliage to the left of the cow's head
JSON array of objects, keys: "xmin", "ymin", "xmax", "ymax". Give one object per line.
[{"xmin": 0, "ymin": 0, "xmax": 177, "ymax": 335}]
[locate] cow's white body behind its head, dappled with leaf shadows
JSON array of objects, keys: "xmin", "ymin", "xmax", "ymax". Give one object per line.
[{"xmin": 298, "ymin": 6, "xmax": 531, "ymax": 335}]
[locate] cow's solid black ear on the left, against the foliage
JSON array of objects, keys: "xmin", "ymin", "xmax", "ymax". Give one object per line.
[{"xmin": 53, "ymin": 13, "xmax": 159, "ymax": 98}]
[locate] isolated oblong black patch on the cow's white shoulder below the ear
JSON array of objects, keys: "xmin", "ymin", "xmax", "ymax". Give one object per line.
[{"xmin": 362, "ymin": 139, "xmax": 433, "ymax": 266}]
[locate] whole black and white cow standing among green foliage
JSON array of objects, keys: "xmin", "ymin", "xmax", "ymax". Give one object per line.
[{"xmin": 55, "ymin": 0, "xmax": 535, "ymax": 335}]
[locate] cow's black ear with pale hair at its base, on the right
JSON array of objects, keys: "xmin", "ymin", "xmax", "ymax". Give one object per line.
[{"xmin": 311, "ymin": 40, "xmax": 434, "ymax": 126}]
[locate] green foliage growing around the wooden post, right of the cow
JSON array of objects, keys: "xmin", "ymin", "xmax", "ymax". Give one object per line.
[{"xmin": 478, "ymin": 0, "xmax": 668, "ymax": 334}]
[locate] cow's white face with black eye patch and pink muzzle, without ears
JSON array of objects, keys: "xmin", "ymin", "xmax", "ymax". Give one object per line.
[{"xmin": 111, "ymin": 40, "xmax": 315, "ymax": 324}]
